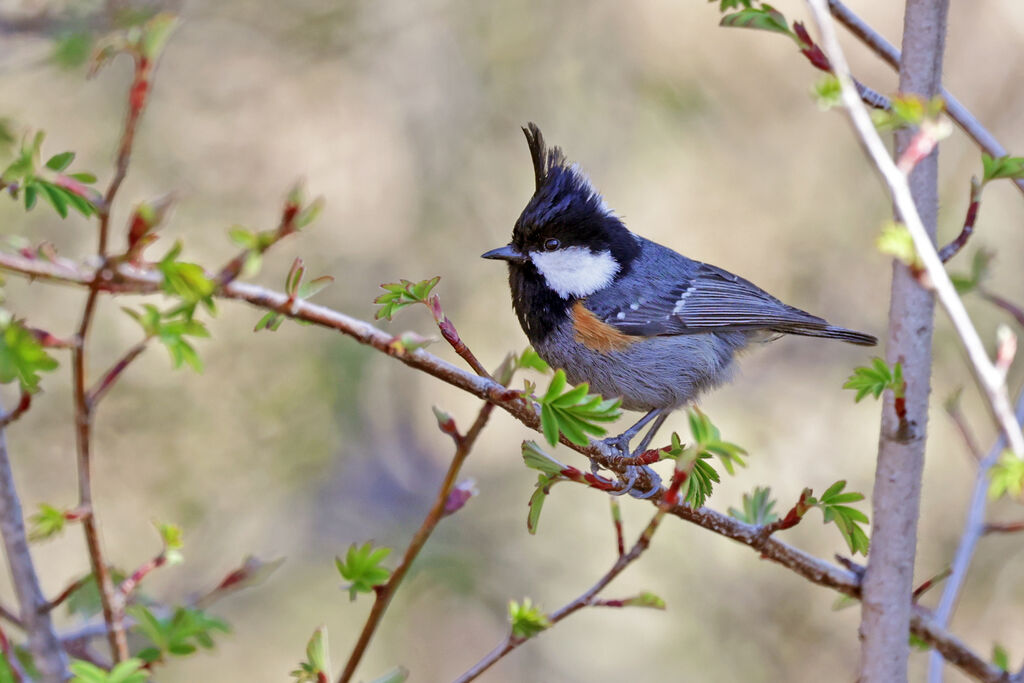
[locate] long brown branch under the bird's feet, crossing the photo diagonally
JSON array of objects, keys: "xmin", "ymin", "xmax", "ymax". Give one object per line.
[{"xmin": 0, "ymin": 253, "xmax": 1002, "ymax": 682}]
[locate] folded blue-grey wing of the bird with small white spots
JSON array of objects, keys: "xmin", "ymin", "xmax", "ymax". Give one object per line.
[{"xmin": 586, "ymin": 262, "xmax": 829, "ymax": 337}]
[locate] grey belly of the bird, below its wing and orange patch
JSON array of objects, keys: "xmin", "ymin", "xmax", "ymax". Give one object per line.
[{"xmin": 537, "ymin": 326, "xmax": 749, "ymax": 411}]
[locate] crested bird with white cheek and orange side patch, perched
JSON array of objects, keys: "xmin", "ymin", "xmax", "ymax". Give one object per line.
[{"xmin": 482, "ymin": 123, "xmax": 878, "ymax": 498}]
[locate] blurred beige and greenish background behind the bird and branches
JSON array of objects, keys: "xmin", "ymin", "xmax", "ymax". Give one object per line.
[{"xmin": 0, "ymin": 0, "xmax": 1024, "ymax": 683}]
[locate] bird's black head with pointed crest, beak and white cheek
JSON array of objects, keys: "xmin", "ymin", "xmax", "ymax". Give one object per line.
[{"xmin": 483, "ymin": 123, "xmax": 640, "ymax": 299}]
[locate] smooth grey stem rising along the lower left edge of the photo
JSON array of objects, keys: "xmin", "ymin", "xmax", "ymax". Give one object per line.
[{"xmin": 0, "ymin": 393, "xmax": 68, "ymax": 683}]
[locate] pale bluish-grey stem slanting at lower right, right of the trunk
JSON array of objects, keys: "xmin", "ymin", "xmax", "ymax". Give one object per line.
[{"xmin": 928, "ymin": 391, "xmax": 1024, "ymax": 683}]
